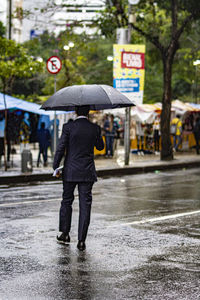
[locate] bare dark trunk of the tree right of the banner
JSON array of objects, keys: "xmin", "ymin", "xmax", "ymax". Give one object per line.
[{"xmin": 160, "ymin": 56, "xmax": 173, "ymax": 160}]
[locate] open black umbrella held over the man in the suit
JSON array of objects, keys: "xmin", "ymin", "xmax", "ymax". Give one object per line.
[{"xmin": 41, "ymin": 84, "xmax": 135, "ymax": 111}]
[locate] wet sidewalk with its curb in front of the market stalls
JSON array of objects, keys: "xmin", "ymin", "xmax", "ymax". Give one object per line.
[{"xmin": 0, "ymin": 146, "xmax": 200, "ymax": 185}]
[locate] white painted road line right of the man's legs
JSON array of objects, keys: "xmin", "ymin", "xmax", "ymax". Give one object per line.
[{"xmin": 109, "ymin": 210, "xmax": 200, "ymax": 227}]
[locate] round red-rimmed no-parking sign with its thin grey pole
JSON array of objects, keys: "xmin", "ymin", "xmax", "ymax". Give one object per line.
[{"xmin": 47, "ymin": 56, "xmax": 62, "ymax": 156}]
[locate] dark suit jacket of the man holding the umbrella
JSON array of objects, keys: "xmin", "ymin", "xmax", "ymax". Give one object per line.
[{"xmin": 53, "ymin": 118, "xmax": 104, "ymax": 182}]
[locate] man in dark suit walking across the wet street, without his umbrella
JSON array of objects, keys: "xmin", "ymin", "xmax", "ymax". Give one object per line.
[{"xmin": 53, "ymin": 106, "xmax": 104, "ymax": 251}]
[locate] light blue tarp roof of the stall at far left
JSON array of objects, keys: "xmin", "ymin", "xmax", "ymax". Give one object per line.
[{"xmin": 0, "ymin": 93, "xmax": 64, "ymax": 116}]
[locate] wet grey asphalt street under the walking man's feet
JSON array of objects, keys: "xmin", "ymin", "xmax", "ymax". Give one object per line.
[{"xmin": 0, "ymin": 169, "xmax": 200, "ymax": 300}]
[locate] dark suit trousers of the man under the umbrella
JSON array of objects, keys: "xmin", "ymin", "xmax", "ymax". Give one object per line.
[{"xmin": 59, "ymin": 180, "xmax": 94, "ymax": 241}]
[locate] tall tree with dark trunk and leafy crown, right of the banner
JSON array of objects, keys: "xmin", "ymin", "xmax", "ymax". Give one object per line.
[{"xmin": 95, "ymin": 0, "xmax": 200, "ymax": 160}]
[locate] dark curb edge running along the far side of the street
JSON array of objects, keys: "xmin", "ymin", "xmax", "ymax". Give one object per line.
[{"xmin": 0, "ymin": 161, "xmax": 200, "ymax": 185}]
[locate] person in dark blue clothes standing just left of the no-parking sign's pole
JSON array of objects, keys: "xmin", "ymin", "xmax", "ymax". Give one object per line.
[{"xmin": 37, "ymin": 122, "xmax": 51, "ymax": 167}]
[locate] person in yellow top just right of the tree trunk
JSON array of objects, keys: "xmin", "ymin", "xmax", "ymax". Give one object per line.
[{"xmin": 170, "ymin": 115, "xmax": 183, "ymax": 152}]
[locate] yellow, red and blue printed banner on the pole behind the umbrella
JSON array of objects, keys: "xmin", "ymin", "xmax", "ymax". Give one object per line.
[{"xmin": 113, "ymin": 44, "xmax": 145, "ymax": 104}]
